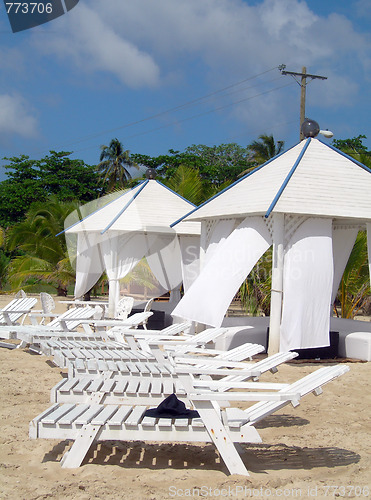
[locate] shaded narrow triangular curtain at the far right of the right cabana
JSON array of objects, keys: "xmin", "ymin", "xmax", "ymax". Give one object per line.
[{"xmin": 331, "ymin": 227, "xmax": 358, "ymax": 304}]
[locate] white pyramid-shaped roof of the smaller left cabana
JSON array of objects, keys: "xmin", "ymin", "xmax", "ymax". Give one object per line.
[{"xmin": 65, "ymin": 179, "xmax": 200, "ymax": 235}]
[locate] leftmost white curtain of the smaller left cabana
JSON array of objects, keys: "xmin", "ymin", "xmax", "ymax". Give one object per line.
[{"xmin": 75, "ymin": 232, "xmax": 104, "ymax": 298}]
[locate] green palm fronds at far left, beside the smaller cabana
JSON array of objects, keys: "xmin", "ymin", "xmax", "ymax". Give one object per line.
[{"xmin": 7, "ymin": 197, "xmax": 78, "ymax": 296}]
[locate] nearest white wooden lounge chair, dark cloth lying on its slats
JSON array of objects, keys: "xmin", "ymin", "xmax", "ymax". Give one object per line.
[{"xmin": 30, "ymin": 365, "xmax": 348, "ymax": 476}]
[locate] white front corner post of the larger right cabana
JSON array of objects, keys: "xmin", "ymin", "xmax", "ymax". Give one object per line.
[{"xmin": 268, "ymin": 213, "xmax": 285, "ymax": 356}]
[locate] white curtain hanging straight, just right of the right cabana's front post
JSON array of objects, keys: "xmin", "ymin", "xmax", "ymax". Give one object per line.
[{"xmin": 280, "ymin": 218, "xmax": 334, "ymax": 351}]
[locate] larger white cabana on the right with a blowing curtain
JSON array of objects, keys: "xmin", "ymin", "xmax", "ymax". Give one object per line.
[{"xmin": 173, "ymin": 138, "xmax": 371, "ymax": 353}]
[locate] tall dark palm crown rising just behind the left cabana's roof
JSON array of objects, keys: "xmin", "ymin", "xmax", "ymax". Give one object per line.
[{"xmin": 97, "ymin": 139, "xmax": 139, "ymax": 191}]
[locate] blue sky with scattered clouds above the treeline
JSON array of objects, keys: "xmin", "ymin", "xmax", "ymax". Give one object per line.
[{"xmin": 0, "ymin": 0, "xmax": 371, "ymax": 180}]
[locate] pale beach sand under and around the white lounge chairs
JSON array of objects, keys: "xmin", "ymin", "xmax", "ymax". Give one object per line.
[{"xmin": 0, "ymin": 297, "xmax": 371, "ymax": 500}]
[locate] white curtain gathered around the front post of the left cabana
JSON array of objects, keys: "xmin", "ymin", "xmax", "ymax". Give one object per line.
[{"xmin": 101, "ymin": 231, "xmax": 146, "ymax": 318}]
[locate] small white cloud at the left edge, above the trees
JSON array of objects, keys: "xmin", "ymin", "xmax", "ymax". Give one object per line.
[{"xmin": 0, "ymin": 94, "xmax": 38, "ymax": 138}]
